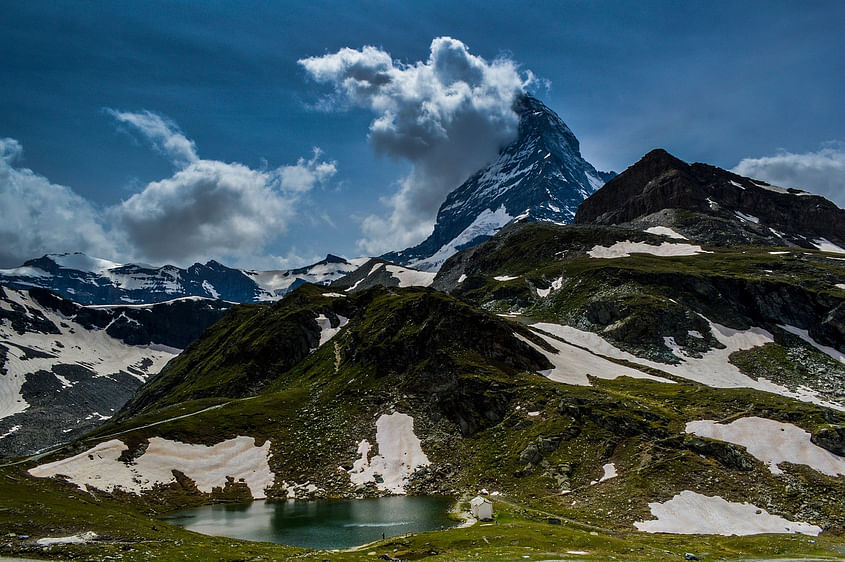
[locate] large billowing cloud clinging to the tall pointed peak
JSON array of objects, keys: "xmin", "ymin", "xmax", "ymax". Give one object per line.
[{"xmin": 299, "ymin": 37, "xmax": 534, "ymax": 254}]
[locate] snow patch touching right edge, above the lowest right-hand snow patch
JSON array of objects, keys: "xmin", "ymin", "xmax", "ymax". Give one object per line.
[{"xmin": 685, "ymin": 417, "xmax": 845, "ymax": 476}]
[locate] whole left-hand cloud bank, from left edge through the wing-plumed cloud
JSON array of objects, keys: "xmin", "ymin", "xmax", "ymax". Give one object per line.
[{"xmin": 0, "ymin": 110, "xmax": 337, "ymax": 267}]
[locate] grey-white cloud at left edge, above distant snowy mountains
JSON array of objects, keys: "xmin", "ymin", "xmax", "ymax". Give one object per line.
[{"xmin": 0, "ymin": 138, "xmax": 116, "ymax": 267}]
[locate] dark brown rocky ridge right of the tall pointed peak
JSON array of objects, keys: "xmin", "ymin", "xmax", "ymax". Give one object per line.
[{"xmin": 575, "ymin": 149, "xmax": 845, "ymax": 247}]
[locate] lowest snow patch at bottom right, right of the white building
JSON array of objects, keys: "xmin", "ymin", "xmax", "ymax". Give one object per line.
[{"xmin": 634, "ymin": 490, "xmax": 822, "ymax": 536}]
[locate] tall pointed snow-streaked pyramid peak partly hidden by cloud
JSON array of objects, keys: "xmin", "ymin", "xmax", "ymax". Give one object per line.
[{"xmin": 382, "ymin": 96, "xmax": 614, "ymax": 270}]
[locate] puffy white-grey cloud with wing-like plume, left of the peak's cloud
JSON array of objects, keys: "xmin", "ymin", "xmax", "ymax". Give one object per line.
[{"xmin": 109, "ymin": 111, "xmax": 337, "ymax": 263}]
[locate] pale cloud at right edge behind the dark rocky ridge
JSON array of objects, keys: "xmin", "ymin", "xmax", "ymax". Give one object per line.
[{"xmin": 731, "ymin": 141, "xmax": 845, "ymax": 207}]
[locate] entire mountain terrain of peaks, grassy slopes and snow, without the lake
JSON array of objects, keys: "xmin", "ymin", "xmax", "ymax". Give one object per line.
[{"xmin": 0, "ymin": 94, "xmax": 845, "ymax": 560}]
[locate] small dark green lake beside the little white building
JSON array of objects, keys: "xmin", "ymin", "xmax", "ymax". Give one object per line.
[{"xmin": 166, "ymin": 496, "xmax": 455, "ymax": 548}]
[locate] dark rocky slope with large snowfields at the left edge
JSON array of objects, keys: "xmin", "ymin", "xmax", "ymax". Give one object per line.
[{"xmin": 0, "ymin": 287, "xmax": 231, "ymax": 456}]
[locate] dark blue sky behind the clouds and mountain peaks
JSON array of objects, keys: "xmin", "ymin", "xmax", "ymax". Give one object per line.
[{"xmin": 0, "ymin": 1, "xmax": 845, "ymax": 267}]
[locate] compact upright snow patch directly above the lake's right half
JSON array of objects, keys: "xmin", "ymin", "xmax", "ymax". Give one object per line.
[{"xmin": 349, "ymin": 412, "xmax": 430, "ymax": 494}]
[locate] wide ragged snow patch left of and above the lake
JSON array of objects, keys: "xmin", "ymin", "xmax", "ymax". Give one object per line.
[{"xmin": 29, "ymin": 437, "xmax": 274, "ymax": 499}]
